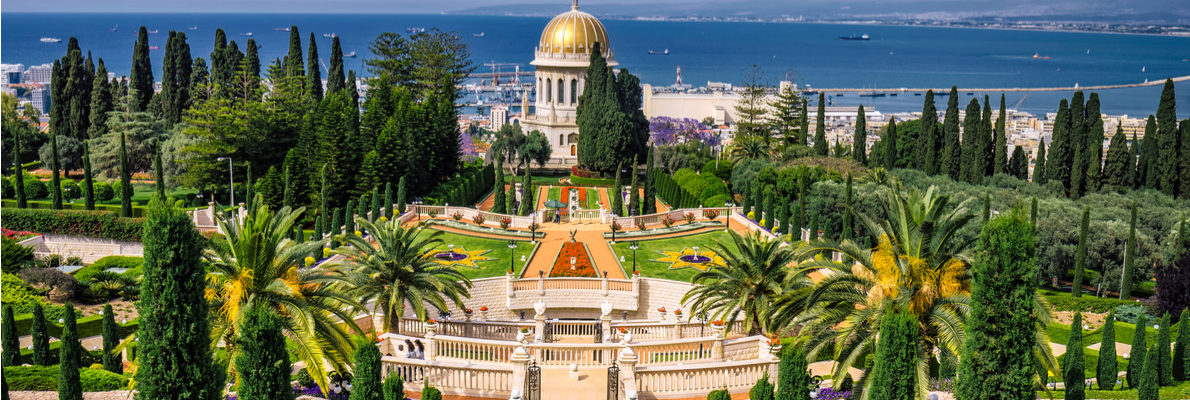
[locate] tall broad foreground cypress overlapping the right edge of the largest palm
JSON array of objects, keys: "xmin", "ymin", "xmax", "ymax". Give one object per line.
[{"xmin": 956, "ymin": 211, "xmax": 1038, "ymax": 400}]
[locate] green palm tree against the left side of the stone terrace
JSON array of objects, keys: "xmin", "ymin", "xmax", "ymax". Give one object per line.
[{"xmin": 332, "ymin": 218, "xmax": 471, "ymax": 332}]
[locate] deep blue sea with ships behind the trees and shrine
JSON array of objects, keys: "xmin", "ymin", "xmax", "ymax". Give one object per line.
[{"xmin": 0, "ymin": 12, "xmax": 1190, "ymax": 118}]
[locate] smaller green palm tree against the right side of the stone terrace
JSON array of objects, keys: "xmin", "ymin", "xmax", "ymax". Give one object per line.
[{"xmin": 682, "ymin": 231, "xmax": 810, "ymax": 335}]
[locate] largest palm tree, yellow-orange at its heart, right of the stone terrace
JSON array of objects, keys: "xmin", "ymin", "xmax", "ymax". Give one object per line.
[{"xmin": 785, "ymin": 186, "xmax": 1054, "ymax": 394}]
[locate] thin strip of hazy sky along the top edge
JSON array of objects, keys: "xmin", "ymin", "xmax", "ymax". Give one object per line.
[{"xmin": 0, "ymin": 0, "xmax": 1190, "ymax": 24}]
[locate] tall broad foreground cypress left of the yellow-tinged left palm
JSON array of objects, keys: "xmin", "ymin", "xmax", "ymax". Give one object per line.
[{"xmin": 136, "ymin": 201, "xmax": 224, "ymax": 400}]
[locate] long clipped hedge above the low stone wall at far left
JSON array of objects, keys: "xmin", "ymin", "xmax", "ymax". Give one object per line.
[{"xmin": 4, "ymin": 205, "xmax": 144, "ymax": 242}]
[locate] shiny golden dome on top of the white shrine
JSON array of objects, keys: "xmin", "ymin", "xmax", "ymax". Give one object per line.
[{"xmin": 538, "ymin": 0, "xmax": 610, "ymax": 56}]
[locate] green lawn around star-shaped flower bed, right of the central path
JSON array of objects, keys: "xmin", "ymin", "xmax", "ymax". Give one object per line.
[{"xmin": 612, "ymin": 231, "xmax": 735, "ymax": 282}]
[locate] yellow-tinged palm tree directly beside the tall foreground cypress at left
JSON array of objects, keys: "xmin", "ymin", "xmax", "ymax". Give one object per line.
[{"xmin": 203, "ymin": 194, "xmax": 363, "ymax": 390}]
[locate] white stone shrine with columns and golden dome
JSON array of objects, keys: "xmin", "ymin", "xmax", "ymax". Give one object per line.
[{"xmin": 520, "ymin": 0, "xmax": 618, "ymax": 165}]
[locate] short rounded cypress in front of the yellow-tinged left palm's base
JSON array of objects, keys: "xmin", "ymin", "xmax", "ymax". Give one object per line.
[{"xmin": 236, "ymin": 307, "xmax": 294, "ymax": 400}]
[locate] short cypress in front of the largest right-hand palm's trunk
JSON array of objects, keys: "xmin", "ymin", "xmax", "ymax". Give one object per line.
[{"xmin": 869, "ymin": 310, "xmax": 917, "ymax": 400}]
